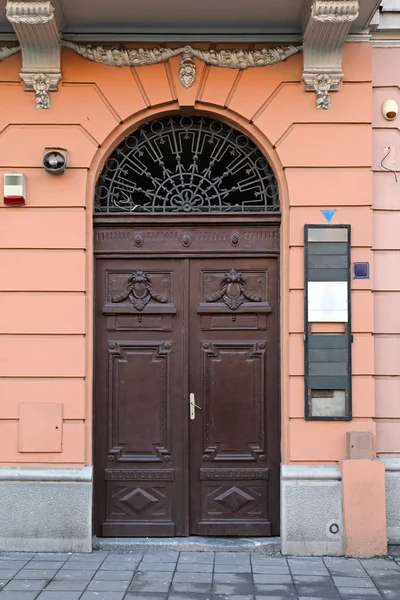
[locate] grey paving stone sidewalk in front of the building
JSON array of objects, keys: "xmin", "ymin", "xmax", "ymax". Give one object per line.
[{"xmin": 0, "ymin": 551, "xmax": 400, "ymax": 600}]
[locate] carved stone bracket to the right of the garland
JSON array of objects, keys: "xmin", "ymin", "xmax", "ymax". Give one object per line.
[{"xmin": 302, "ymin": 0, "xmax": 359, "ymax": 110}]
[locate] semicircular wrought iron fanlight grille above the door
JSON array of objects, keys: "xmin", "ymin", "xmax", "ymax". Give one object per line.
[{"xmin": 95, "ymin": 117, "xmax": 279, "ymax": 213}]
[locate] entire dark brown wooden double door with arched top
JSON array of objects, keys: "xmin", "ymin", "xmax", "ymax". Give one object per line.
[{"xmin": 94, "ymin": 119, "xmax": 280, "ymax": 537}]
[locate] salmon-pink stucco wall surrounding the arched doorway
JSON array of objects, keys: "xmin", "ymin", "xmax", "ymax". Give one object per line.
[{"xmin": 0, "ymin": 43, "xmax": 376, "ymax": 466}]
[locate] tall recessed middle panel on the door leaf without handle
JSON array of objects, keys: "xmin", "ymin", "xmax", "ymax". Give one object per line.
[{"xmin": 108, "ymin": 340, "xmax": 172, "ymax": 462}]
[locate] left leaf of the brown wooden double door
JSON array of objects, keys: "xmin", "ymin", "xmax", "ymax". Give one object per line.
[{"xmin": 95, "ymin": 259, "xmax": 187, "ymax": 536}]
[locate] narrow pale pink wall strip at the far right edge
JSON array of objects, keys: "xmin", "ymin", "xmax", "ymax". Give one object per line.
[{"xmin": 373, "ymin": 46, "xmax": 400, "ymax": 456}]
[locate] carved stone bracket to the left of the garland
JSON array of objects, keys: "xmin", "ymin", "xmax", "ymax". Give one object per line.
[{"xmin": 6, "ymin": 0, "xmax": 61, "ymax": 109}]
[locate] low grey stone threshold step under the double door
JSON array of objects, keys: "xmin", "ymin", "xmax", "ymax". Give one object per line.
[{"xmin": 93, "ymin": 536, "xmax": 281, "ymax": 555}]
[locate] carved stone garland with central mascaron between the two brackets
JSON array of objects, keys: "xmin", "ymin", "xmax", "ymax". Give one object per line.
[{"xmin": 62, "ymin": 41, "xmax": 301, "ymax": 88}]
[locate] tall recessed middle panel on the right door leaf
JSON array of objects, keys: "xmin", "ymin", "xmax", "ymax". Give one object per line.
[{"xmin": 200, "ymin": 340, "xmax": 265, "ymax": 462}]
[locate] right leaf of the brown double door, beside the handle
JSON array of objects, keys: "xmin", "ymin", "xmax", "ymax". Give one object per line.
[{"xmin": 189, "ymin": 257, "xmax": 279, "ymax": 535}]
